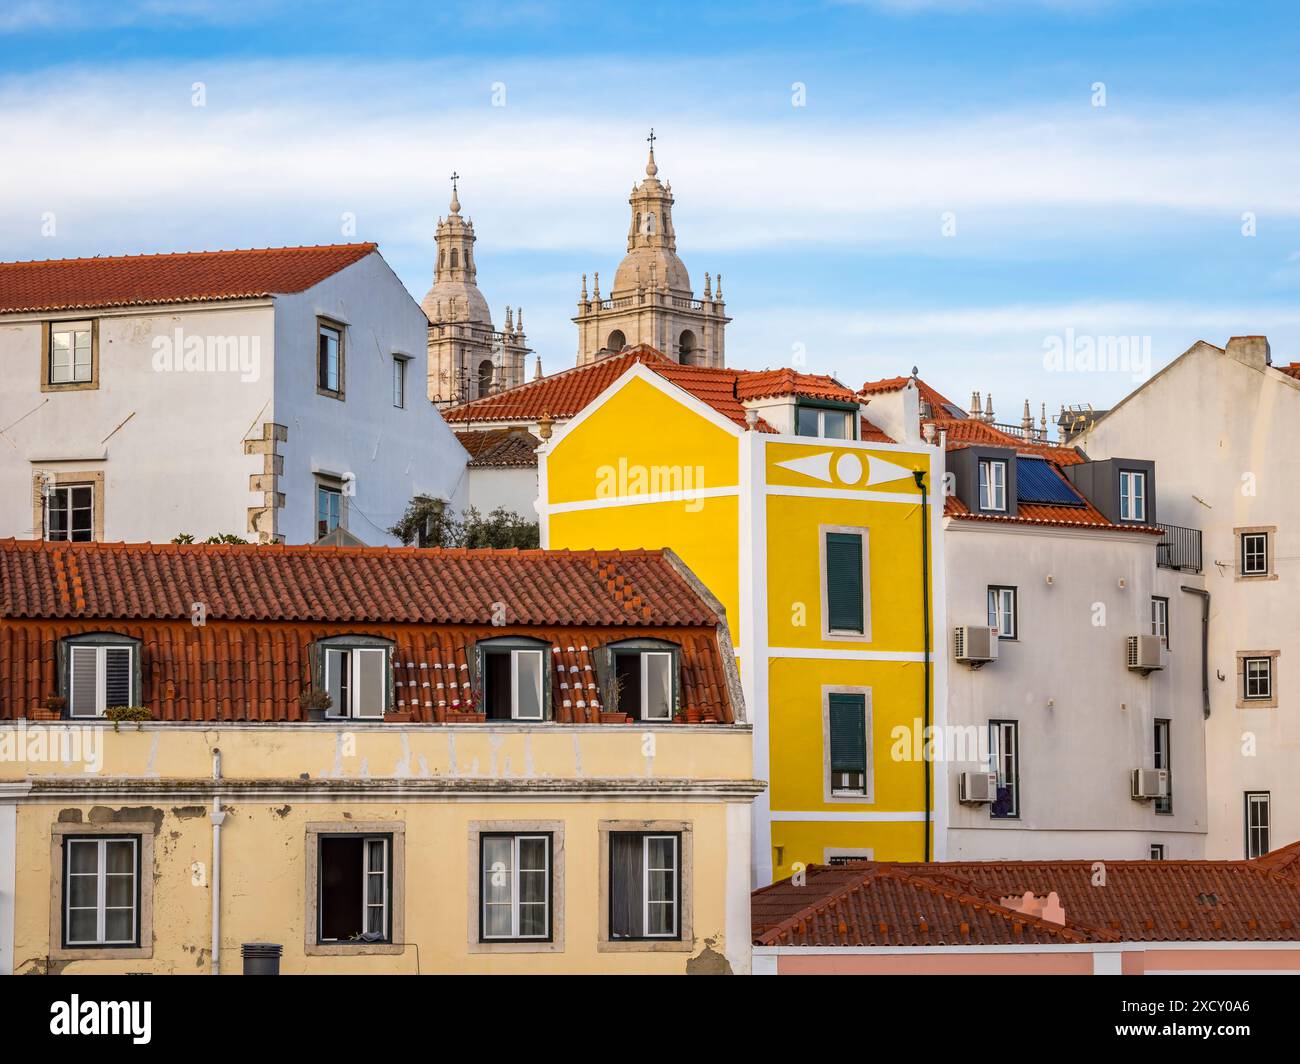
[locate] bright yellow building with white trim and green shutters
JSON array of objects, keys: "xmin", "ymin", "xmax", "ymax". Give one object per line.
[{"xmin": 538, "ymin": 352, "xmax": 944, "ymax": 884}]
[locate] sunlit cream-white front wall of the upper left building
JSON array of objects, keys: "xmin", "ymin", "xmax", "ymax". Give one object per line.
[{"xmin": 0, "ymin": 302, "xmax": 274, "ymax": 542}]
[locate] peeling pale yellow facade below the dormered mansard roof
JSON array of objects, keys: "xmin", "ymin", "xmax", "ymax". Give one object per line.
[{"xmin": 0, "ymin": 722, "xmax": 758, "ymax": 974}]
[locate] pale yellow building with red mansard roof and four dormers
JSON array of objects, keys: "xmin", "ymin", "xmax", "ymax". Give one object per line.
[{"xmin": 0, "ymin": 540, "xmax": 762, "ymax": 974}]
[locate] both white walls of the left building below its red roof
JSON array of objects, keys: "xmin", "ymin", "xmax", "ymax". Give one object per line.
[{"xmin": 0, "ymin": 254, "xmax": 467, "ymax": 544}]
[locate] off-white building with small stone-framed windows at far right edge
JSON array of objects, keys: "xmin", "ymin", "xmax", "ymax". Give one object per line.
[{"xmin": 1075, "ymin": 337, "xmax": 1300, "ymax": 858}]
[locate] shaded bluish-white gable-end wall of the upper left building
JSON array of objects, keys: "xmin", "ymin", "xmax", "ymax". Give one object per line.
[{"xmin": 269, "ymin": 254, "xmax": 467, "ymax": 545}]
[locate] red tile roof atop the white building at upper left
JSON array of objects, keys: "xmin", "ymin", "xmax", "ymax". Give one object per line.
[{"xmin": 0, "ymin": 243, "xmax": 377, "ymax": 313}]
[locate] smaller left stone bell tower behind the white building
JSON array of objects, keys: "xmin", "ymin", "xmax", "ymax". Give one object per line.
[{"xmin": 420, "ymin": 176, "xmax": 541, "ymax": 406}]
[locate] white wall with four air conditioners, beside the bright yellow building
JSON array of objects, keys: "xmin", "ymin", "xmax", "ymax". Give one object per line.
[{"xmin": 943, "ymin": 517, "xmax": 1205, "ymax": 860}]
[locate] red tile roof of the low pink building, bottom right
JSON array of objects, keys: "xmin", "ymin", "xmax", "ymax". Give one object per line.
[{"xmin": 751, "ymin": 855, "xmax": 1300, "ymax": 946}]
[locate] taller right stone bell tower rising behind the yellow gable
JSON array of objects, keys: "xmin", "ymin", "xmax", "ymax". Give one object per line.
[{"xmin": 573, "ymin": 130, "xmax": 731, "ymax": 367}]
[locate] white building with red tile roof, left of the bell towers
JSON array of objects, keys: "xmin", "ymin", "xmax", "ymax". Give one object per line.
[{"xmin": 0, "ymin": 243, "xmax": 467, "ymax": 544}]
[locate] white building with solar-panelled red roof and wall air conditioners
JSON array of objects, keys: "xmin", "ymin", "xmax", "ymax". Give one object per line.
[{"xmin": 862, "ymin": 377, "xmax": 1206, "ymax": 860}]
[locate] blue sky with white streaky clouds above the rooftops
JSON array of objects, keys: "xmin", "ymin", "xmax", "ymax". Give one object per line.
[{"xmin": 0, "ymin": 0, "xmax": 1300, "ymax": 420}]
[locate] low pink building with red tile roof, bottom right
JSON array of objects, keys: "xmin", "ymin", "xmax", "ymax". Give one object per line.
[{"xmin": 751, "ymin": 843, "xmax": 1300, "ymax": 976}]
